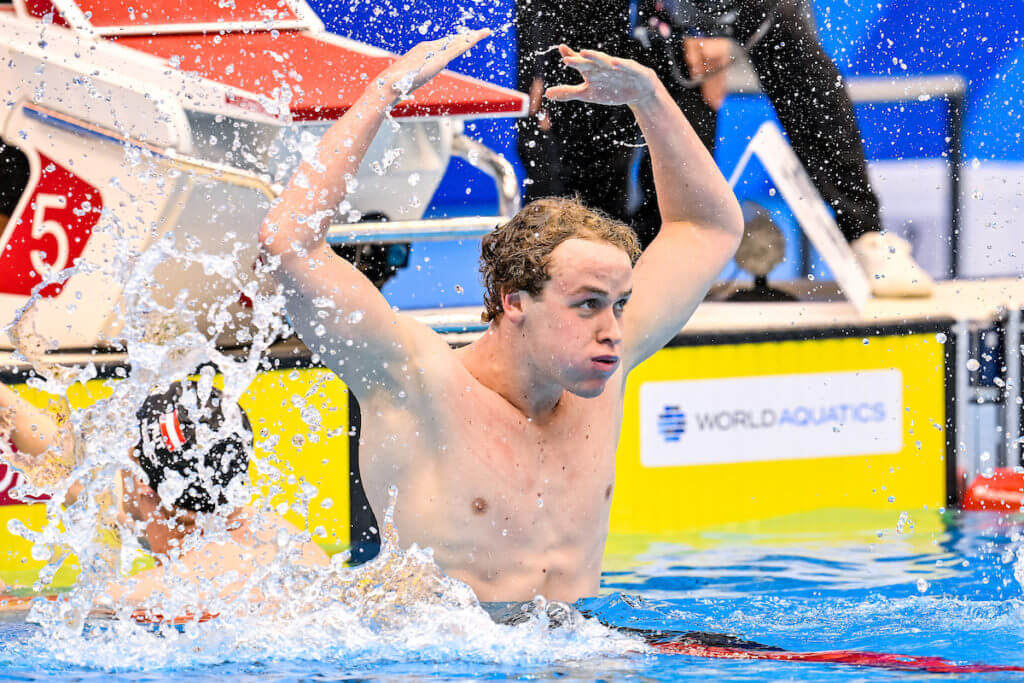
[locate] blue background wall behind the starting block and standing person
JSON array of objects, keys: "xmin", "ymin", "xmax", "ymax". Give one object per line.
[{"xmin": 312, "ymin": 0, "xmax": 1024, "ymax": 307}]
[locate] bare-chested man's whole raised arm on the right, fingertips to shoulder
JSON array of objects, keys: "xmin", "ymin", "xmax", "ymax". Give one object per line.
[{"xmin": 546, "ymin": 45, "xmax": 743, "ymax": 371}]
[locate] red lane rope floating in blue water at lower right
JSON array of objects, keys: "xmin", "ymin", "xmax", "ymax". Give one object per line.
[{"xmin": 652, "ymin": 643, "xmax": 1024, "ymax": 674}]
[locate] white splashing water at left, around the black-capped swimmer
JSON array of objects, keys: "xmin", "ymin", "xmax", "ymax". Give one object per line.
[{"xmin": 0, "ymin": 178, "xmax": 645, "ymax": 671}]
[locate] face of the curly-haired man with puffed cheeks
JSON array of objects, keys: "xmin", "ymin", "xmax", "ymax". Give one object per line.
[{"xmin": 522, "ymin": 238, "xmax": 633, "ymax": 398}]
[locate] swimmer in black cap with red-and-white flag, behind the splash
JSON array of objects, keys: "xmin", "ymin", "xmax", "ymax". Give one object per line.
[{"xmin": 0, "ymin": 381, "xmax": 329, "ymax": 605}]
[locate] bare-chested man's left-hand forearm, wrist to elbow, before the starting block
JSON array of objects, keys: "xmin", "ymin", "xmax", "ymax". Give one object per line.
[{"xmin": 260, "ymin": 81, "xmax": 399, "ymax": 254}]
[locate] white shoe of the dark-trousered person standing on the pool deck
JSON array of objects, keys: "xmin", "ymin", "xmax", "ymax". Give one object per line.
[{"xmin": 850, "ymin": 230, "xmax": 935, "ymax": 297}]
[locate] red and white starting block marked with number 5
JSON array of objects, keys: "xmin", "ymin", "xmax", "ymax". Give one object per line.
[{"xmin": 0, "ymin": 0, "xmax": 526, "ymax": 348}]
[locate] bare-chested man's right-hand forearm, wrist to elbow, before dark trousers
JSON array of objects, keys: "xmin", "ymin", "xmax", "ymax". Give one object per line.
[{"xmin": 630, "ymin": 76, "xmax": 743, "ymax": 236}]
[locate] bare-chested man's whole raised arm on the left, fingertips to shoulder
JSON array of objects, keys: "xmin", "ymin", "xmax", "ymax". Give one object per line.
[{"xmin": 260, "ymin": 29, "xmax": 490, "ymax": 395}]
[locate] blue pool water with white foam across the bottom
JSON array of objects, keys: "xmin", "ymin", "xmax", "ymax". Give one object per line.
[{"xmin": 0, "ymin": 512, "xmax": 1024, "ymax": 681}]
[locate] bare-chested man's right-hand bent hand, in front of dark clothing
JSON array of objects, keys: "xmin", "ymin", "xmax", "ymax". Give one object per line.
[{"xmin": 544, "ymin": 45, "xmax": 658, "ymax": 105}]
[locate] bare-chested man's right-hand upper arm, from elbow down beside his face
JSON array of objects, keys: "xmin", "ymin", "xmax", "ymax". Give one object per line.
[{"xmin": 623, "ymin": 222, "xmax": 738, "ymax": 372}]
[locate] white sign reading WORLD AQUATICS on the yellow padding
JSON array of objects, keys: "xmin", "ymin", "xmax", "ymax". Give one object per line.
[{"xmin": 640, "ymin": 370, "xmax": 903, "ymax": 467}]
